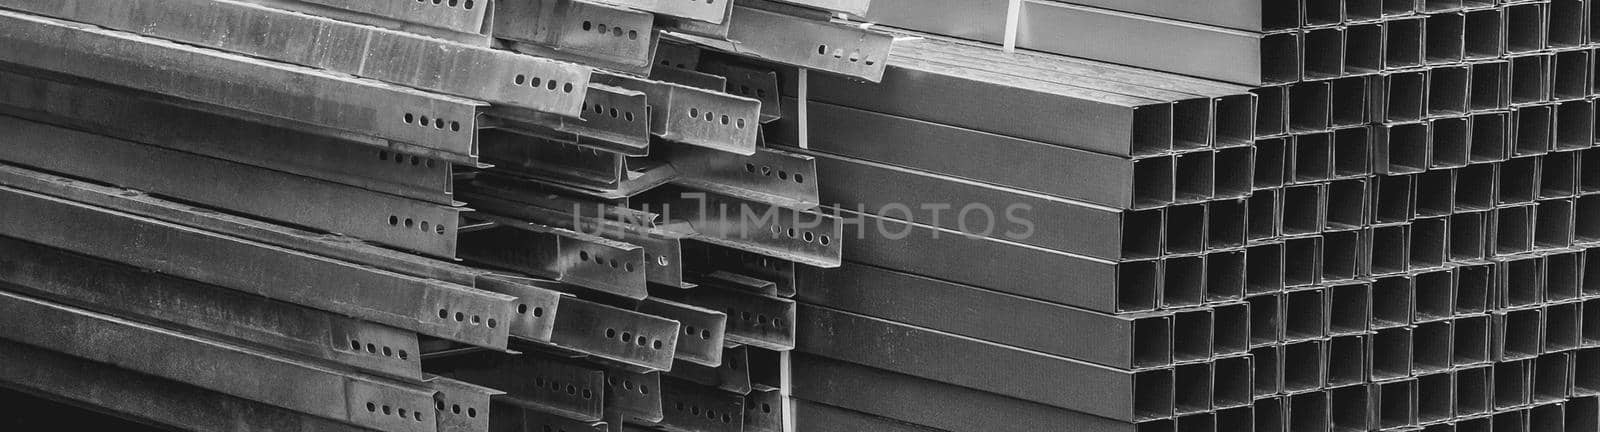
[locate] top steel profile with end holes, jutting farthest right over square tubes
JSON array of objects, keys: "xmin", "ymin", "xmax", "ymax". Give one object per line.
[{"xmin": 674, "ymin": 5, "xmax": 894, "ymax": 83}]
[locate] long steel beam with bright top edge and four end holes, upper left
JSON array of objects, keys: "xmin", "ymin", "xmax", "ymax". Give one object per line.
[{"xmin": 0, "ymin": 11, "xmax": 486, "ymax": 165}]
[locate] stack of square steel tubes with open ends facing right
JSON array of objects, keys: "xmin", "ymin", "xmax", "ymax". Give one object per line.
[{"xmin": 780, "ymin": 0, "xmax": 1600, "ymax": 432}]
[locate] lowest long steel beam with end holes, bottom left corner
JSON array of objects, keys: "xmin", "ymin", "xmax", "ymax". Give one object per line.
[{"xmin": 0, "ymin": 293, "xmax": 435, "ymax": 432}]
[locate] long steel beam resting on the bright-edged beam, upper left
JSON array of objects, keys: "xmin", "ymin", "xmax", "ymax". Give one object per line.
[{"xmin": 5, "ymin": 0, "xmax": 589, "ymax": 117}]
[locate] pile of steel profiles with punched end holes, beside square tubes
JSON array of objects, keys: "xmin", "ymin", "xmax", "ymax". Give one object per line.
[{"xmin": 0, "ymin": 0, "xmax": 893, "ymax": 432}]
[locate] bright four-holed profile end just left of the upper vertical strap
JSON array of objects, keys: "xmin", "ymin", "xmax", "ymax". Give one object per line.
[{"xmin": 594, "ymin": 74, "xmax": 762, "ymax": 155}]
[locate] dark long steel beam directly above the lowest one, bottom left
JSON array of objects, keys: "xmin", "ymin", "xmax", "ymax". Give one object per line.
[{"xmin": 0, "ymin": 237, "xmax": 422, "ymax": 381}]
